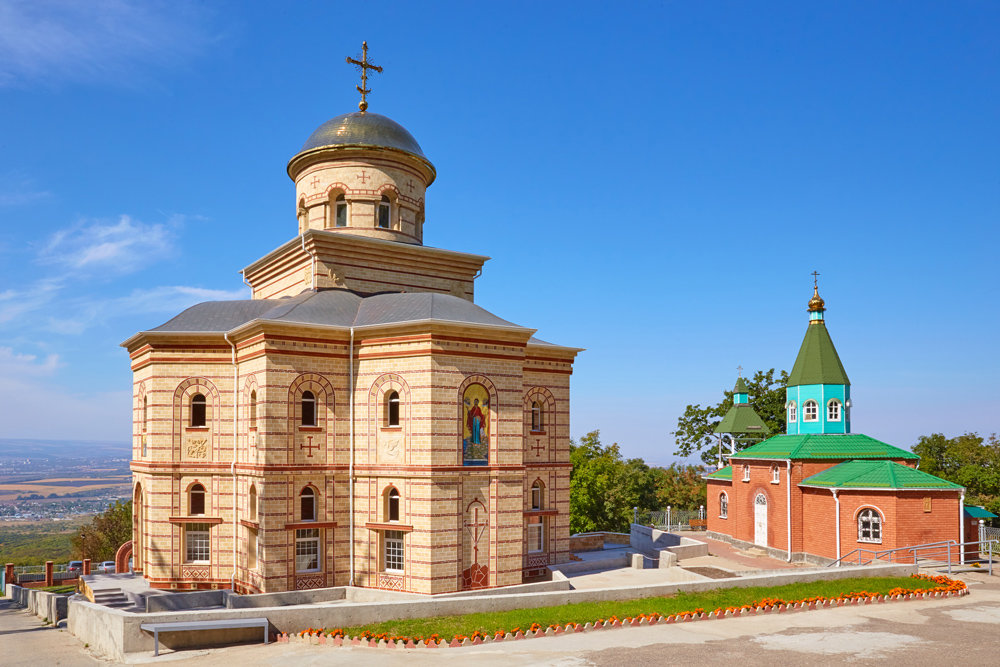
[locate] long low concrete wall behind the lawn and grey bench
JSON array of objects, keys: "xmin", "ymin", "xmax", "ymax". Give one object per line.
[{"xmin": 68, "ymin": 564, "xmax": 916, "ymax": 661}]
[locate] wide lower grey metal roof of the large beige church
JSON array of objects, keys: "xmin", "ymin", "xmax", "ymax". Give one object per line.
[{"xmin": 151, "ymin": 289, "xmax": 524, "ymax": 333}]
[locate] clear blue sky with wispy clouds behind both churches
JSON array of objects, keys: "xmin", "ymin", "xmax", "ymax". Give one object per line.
[{"xmin": 0, "ymin": 0, "xmax": 1000, "ymax": 463}]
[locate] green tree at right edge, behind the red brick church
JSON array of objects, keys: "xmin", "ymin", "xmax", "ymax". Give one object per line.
[{"xmin": 913, "ymin": 433, "xmax": 1000, "ymax": 514}]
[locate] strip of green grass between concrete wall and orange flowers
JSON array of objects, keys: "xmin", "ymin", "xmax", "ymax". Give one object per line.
[{"xmin": 330, "ymin": 577, "xmax": 941, "ymax": 639}]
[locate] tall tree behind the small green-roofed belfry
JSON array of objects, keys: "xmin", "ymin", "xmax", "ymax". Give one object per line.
[{"xmin": 673, "ymin": 368, "xmax": 788, "ymax": 464}]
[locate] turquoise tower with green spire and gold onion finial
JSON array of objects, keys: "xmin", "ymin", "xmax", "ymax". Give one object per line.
[{"xmin": 785, "ymin": 274, "xmax": 851, "ymax": 435}]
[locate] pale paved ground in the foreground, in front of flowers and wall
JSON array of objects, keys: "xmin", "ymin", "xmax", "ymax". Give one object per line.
[{"xmin": 7, "ymin": 573, "xmax": 1000, "ymax": 667}]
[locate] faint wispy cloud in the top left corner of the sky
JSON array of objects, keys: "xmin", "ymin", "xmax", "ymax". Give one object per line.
[{"xmin": 0, "ymin": 0, "xmax": 216, "ymax": 86}]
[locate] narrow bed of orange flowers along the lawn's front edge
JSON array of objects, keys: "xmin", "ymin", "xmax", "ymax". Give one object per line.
[{"xmin": 278, "ymin": 574, "xmax": 968, "ymax": 648}]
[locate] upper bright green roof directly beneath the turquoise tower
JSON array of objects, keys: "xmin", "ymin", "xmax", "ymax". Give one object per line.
[{"xmin": 733, "ymin": 433, "xmax": 920, "ymax": 460}]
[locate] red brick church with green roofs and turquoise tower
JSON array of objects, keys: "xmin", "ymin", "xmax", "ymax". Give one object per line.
[{"xmin": 706, "ymin": 289, "xmax": 976, "ymax": 560}]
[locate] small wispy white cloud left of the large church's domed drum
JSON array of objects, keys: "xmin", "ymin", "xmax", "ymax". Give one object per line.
[{"xmin": 39, "ymin": 215, "xmax": 182, "ymax": 273}]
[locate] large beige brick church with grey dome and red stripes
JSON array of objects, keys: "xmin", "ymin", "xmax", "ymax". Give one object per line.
[{"xmin": 123, "ymin": 51, "xmax": 580, "ymax": 594}]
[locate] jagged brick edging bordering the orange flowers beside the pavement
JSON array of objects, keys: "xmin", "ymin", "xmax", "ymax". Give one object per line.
[{"xmin": 277, "ymin": 577, "xmax": 969, "ymax": 649}]
